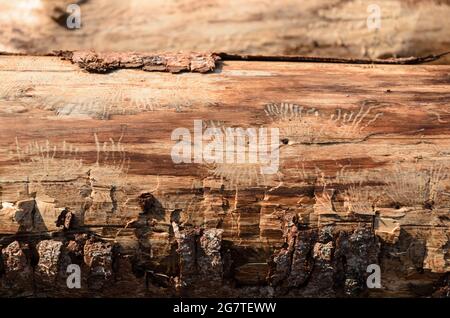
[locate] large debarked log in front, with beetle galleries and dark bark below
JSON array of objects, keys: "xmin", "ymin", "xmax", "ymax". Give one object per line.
[{"xmin": 0, "ymin": 52, "xmax": 450, "ymax": 297}]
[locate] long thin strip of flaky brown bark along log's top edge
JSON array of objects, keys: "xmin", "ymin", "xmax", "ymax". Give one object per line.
[{"xmin": 55, "ymin": 51, "xmax": 219, "ymax": 73}]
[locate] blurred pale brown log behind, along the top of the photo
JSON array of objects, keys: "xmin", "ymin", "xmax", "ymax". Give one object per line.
[{"xmin": 0, "ymin": 0, "xmax": 450, "ymax": 64}]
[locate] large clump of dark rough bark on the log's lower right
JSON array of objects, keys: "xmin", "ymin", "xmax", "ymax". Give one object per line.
[{"xmin": 268, "ymin": 225, "xmax": 380, "ymax": 296}]
